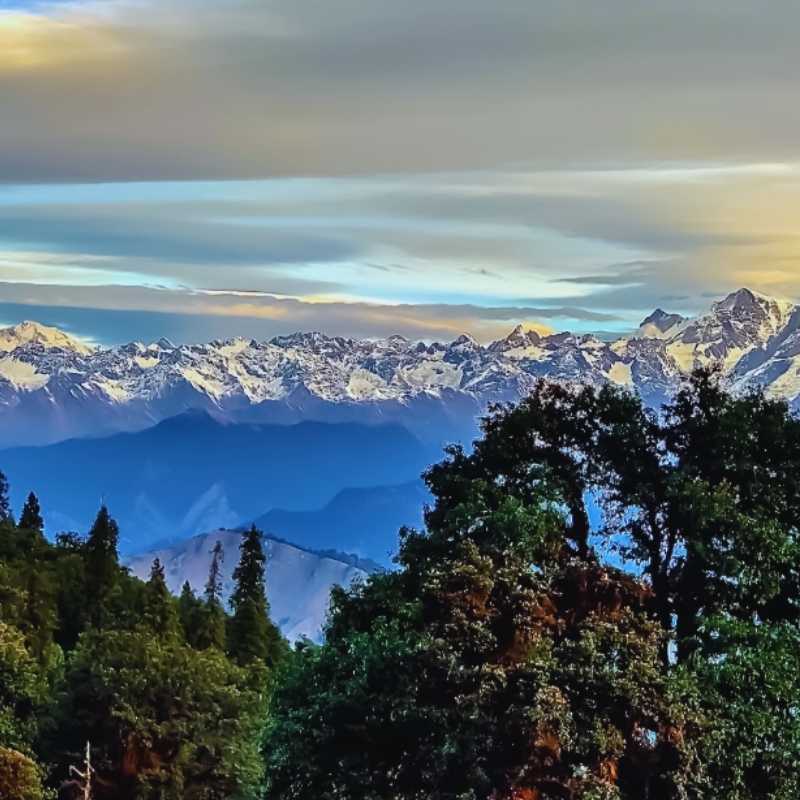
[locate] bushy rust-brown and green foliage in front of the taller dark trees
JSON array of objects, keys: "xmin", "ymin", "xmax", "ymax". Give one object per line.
[{"xmin": 266, "ymin": 484, "xmax": 695, "ymax": 800}]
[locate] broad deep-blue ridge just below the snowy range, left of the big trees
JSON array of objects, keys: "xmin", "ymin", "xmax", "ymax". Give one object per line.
[{"xmin": 0, "ymin": 412, "xmax": 433, "ymax": 552}]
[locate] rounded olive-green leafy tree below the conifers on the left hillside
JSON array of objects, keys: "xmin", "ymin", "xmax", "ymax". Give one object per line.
[{"xmin": 61, "ymin": 627, "xmax": 267, "ymax": 800}]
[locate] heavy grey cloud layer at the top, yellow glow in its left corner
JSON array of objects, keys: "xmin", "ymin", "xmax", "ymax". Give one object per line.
[{"xmin": 0, "ymin": 0, "xmax": 800, "ymax": 181}]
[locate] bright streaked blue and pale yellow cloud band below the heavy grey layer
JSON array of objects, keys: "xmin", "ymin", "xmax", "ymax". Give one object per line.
[{"xmin": 0, "ymin": 163, "xmax": 800, "ymax": 338}]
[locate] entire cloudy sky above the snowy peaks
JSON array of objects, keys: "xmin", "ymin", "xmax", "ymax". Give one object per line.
[{"xmin": 0, "ymin": 0, "xmax": 800, "ymax": 344}]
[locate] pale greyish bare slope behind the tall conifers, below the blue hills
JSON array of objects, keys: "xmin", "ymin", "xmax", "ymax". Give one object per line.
[{"xmin": 125, "ymin": 530, "xmax": 367, "ymax": 641}]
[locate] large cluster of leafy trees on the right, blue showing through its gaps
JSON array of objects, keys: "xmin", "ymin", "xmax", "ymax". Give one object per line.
[{"xmin": 265, "ymin": 372, "xmax": 800, "ymax": 800}]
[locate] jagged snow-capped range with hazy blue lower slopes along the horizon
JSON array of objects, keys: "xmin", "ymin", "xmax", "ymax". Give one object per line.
[{"xmin": 0, "ymin": 289, "xmax": 800, "ymax": 446}]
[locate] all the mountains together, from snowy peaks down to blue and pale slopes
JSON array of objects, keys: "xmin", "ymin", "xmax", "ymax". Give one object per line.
[{"xmin": 0, "ymin": 289, "xmax": 800, "ymax": 638}]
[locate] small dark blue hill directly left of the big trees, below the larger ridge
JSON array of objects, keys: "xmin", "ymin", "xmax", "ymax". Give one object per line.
[{"xmin": 255, "ymin": 480, "xmax": 430, "ymax": 564}]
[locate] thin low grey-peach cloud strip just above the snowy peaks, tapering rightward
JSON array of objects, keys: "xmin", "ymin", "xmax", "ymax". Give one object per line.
[{"xmin": 0, "ymin": 283, "xmax": 616, "ymax": 342}]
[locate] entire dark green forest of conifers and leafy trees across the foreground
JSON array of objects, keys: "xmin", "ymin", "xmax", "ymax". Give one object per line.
[{"xmin": 0, "ymin": 372, "xmax": 800, "ymax": 800}]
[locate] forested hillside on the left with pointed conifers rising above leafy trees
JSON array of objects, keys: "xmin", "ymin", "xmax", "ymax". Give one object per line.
[{"xmin": 0, "ymin": 496, "xmax": 288, "ymax": 800}]
